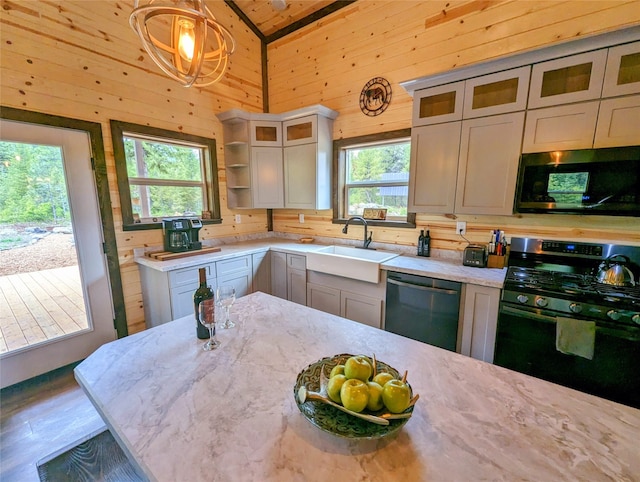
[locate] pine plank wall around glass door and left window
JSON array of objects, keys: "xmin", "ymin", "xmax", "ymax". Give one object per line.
[{"xmin": 0, "ymin": 0, "xmax": 267, "ymax": 333}]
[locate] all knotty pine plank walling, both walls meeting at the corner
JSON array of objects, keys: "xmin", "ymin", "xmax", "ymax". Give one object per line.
[{"xmin": 0, "ymin": 0, "xmax": 640, "ymax": 333}]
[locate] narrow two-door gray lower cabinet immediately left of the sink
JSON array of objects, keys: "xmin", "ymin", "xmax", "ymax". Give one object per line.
[{"xmin": 271, "ymin": 251, "xmax": 307, "ymax": 305}]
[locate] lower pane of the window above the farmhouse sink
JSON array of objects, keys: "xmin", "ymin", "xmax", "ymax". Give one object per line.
[{"xmin": 347, "ymin": 186, "xmax": 409, "ymax": 218}]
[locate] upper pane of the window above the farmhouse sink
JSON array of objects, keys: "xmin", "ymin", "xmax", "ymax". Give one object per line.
[{"xmin": 346, "ymin": 142, "xmax": 411, "ymax": 184}]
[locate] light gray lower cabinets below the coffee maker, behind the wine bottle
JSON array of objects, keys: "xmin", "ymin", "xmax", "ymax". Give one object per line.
[{"xmin": 140, "ymin": 255, "xmax": 253, "ymax": 328}]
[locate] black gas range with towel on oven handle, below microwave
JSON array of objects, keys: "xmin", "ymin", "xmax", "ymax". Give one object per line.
[{"xmin": 494, "ymin": 238, "xmax": 640, "ymax": 408}]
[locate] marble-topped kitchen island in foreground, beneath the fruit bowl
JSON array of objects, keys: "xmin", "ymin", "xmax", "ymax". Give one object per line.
[{"xmin": 75, "ymin": 293, "xmax": 640, "ymax": 482}]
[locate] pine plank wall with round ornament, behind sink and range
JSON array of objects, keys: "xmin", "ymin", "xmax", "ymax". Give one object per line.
[{"xmin": 268, "ymin": 0, "xmax": 640, "ymax": 250}]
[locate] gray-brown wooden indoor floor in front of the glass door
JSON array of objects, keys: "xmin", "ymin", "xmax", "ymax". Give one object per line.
[{"xmin": 0, "ymin": 366, "xmax": 105, "ymax": 482}]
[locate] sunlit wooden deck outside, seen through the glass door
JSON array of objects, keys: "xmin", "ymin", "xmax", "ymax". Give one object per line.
[{"xmin": 0, "ymin": 266, "xmax": 88, "ymax": 353}]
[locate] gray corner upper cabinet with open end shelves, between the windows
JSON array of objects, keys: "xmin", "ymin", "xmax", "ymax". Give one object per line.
[{"xmin": 217, "ymin": 105, "xmax": 338, "ymax": 209}]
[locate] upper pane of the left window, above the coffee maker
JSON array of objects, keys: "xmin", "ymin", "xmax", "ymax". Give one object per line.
[{"xmin": 124, "ymin": 138, "xmax": 202, "ymax": 181}]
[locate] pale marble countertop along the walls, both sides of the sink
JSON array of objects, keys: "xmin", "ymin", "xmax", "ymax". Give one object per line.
[{"xmin": 135, "ymin": 238, "xmax": 507, "ymax": 288}]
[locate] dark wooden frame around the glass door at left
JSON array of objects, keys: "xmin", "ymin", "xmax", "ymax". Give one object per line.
[{"xmin": 0, "ymin": 106, "xmax": 129, "ymax": 338}]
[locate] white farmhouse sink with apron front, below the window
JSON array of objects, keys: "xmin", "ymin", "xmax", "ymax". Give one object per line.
[{"xmin": 307, "ymin": 246, "xmax": 398, "ymax": 283}]
